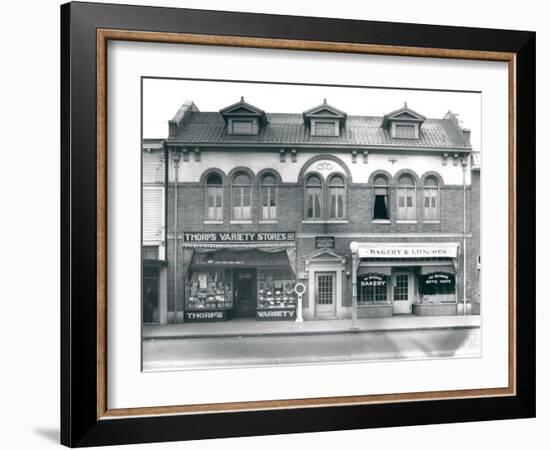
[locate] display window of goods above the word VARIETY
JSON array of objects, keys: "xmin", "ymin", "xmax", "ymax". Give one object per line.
[{"xmin": 258, "ymin": 269, "xmax": 296, "ymax": 308}]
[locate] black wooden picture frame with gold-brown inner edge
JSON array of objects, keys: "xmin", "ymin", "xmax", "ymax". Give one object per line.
[{"xmin": 61, "ymin": 2, "xmax": 535, "ymax": 447}]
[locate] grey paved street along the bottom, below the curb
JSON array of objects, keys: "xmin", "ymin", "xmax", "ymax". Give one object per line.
[{"xmin": 143, "ymin": 328, "xmax": 481, "ymax": 371}]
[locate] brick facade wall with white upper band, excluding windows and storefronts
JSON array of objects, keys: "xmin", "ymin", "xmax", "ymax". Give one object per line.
[{"xmin": 162, "ymin": 150, "xmax": 479, "ymax": 317}]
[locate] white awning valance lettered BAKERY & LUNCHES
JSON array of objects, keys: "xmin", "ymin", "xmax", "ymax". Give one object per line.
[{"xmin": 350, "ymin": 242, "xmax": 458, "ymax": 259}]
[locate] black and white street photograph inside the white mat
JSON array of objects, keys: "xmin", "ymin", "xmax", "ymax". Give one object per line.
[{"xmin": 141, "ymin": 77, "xmax": 483, "ymax": 372}]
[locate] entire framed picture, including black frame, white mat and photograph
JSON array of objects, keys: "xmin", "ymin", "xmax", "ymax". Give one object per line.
[{"xmin": 61, "ymin": 3, "xmax": 535, "ymax": 447}]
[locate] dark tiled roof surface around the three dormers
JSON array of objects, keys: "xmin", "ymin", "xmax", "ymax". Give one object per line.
[{"xmin": 168, "ymin": 112, "xmax": 471, "ymax": 150}]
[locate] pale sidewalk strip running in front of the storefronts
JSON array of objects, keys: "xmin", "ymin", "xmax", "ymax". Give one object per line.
[{"xmin": 143, "ymin": 315, "xmax": 481, "ymax": 339}]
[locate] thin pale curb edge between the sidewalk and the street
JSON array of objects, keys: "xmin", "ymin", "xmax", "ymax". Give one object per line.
[{"xmin": 142, "ymin": 325, "xmax": 480, "ymax": 341}]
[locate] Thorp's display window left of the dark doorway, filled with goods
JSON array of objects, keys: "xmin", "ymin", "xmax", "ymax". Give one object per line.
[{"xmin": 186, "ymin": 269, "xmax": 233, "ymax": 310}]
